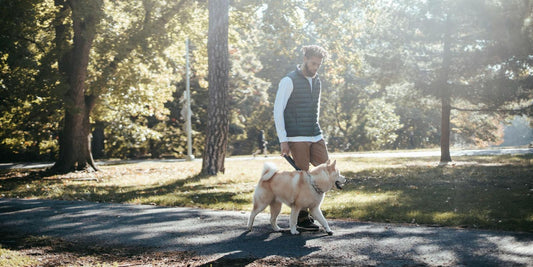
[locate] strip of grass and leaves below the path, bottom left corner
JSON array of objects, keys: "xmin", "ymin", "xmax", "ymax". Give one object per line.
[{"xmin": 0, "ymin": 232, "xmax": 208, "ymax": 267}]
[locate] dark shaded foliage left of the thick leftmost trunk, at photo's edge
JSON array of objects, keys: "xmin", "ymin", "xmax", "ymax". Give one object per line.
[{"xmin": 0, "ymin": 0, "xmax": 61, "ymax": 160}]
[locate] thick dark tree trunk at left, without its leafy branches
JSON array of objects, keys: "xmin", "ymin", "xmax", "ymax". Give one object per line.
[{"xmin": 52, "ymin": 0, "xmax": 102, "ymax": 172}]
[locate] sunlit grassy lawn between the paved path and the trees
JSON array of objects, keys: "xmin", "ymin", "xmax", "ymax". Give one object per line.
[{"xmin": 0, "ymin": 155, "xmax": 533, "ymax": 232}]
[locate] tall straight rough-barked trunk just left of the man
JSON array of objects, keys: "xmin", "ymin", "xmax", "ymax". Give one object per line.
[{"xmin": 202, "ymin": 0, "xmax": 229, "ymax": 175}]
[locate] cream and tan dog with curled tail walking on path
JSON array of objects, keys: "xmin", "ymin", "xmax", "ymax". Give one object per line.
[{"xmin": 248, "ymin": 160, "xmax": 346, "ymax": 235}]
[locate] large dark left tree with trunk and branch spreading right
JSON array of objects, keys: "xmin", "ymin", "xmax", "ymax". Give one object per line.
[{"xmin": 52, "ymin": 0, "xmax": 193, "ymax": 172}]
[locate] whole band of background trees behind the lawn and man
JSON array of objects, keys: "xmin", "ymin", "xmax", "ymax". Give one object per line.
[{"xmin": 0, "ymin": 0, "xmax": 533, "ymax": 166}]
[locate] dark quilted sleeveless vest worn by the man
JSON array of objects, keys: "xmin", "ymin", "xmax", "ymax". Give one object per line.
[{"xmin": 283, "ymin": 70, "xmax": 322, "ymax": 137}]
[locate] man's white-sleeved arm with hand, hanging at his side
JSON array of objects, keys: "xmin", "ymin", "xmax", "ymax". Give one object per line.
[{"xmin": 274, "ymin": 77, "xmax": 293, "ymax": 156}]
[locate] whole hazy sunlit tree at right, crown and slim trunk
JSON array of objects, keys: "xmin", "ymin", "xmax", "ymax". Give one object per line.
[{"xmin": 360, "ymin": 0, "xmax": 531, "ymax": 162}]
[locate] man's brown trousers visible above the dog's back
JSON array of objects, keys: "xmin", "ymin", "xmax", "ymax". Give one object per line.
[{"xmin": 289, "ymin": 139, "xmax": 329, "ymax": 171}]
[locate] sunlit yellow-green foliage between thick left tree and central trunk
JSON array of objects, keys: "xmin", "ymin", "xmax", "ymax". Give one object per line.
[{"xmin": 90, "ymin": 1, "xmax": 202, "ymax": 158}]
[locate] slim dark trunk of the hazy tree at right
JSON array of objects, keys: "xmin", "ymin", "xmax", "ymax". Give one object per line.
[{"xmin": 439, "ymin": 15, "xmax": 452, "ymax": 163}]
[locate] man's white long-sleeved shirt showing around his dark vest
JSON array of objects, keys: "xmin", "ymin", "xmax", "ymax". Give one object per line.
[{"xmin": 274, "ymin": 76, "xmax": 323, "ymax": 143}]
